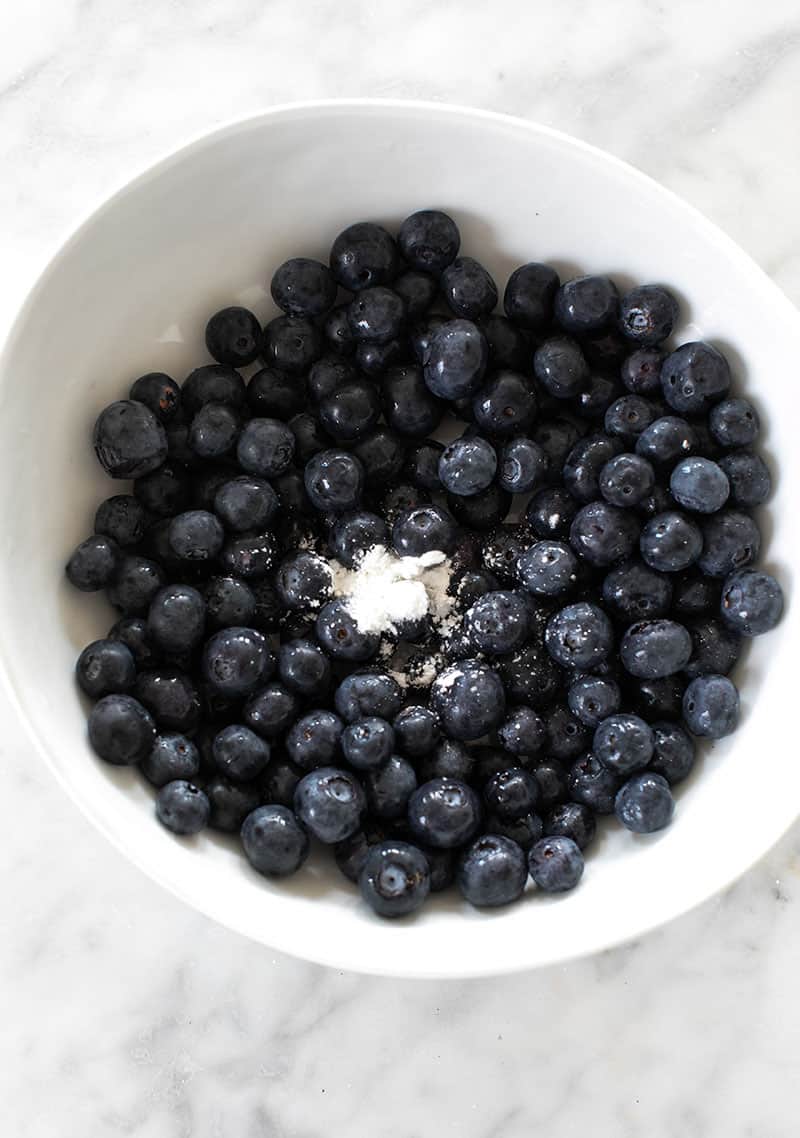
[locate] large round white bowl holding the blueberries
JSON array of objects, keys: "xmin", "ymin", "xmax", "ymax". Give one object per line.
[{"xmin": 0, "ymin": 101, "xmax": 800, "ymax": 976}]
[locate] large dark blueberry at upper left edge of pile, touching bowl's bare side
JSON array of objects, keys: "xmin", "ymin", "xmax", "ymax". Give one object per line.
[{"xmin": 94, "ymin": 399, "xmax": 167, "ymax": 478}]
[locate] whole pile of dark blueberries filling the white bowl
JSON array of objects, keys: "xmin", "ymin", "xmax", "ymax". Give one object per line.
[{"xmin": 67, "ymin": 209, "xmax": 783, "ymax": 916}]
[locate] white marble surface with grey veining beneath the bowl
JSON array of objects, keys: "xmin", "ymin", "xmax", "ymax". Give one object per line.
[{"xmin": 0, "ymin": 0, "xmax": 800, "ymax": 1138}]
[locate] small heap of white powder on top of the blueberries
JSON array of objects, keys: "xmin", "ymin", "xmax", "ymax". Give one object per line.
[{"xmin": 330, "ymin": 545, "xmax": 455, "ymax": 633}]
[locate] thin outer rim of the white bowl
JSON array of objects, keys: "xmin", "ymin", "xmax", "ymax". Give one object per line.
[{"xmin": 0, "ymin": 97, "xmax": 800, "ymax": 980}]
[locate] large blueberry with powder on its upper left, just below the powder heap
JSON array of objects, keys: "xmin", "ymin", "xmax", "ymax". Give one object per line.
[{"xmin": 430, "ymin": 660, "xmax": 505, "ymax": 742}]
